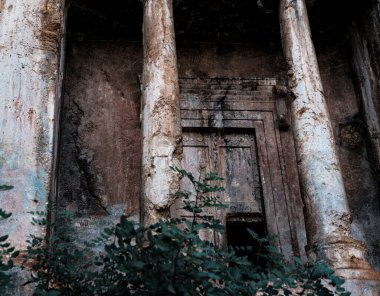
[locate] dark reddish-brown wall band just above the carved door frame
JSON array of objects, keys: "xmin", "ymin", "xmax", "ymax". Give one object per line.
[{"xmin": 177, "ymin": 41, "xmax": 286, "ymax": 79}]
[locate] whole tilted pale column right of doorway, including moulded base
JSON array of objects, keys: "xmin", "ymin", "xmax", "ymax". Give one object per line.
[{"xmin": 280, "ymin": 0, "xmax": 378, "ymax": 279}]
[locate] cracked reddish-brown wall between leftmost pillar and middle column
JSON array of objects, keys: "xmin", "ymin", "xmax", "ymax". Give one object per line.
[{"xmin": 57, "ymin": 41, "xmax": 142, "ymax": 232}]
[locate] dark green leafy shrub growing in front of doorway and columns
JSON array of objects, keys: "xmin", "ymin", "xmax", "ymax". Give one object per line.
[{"xmin": 22, "ymin": 168, "xmax": 349, "ymax": 296}]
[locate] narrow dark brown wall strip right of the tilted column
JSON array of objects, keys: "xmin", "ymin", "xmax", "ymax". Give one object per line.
[{"xmin": 315, "ymin": 47, "xmax": 380, "ymax": 268}]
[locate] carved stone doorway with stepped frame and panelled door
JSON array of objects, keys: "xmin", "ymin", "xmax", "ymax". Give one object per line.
[{"xmin": 173, "ymin": 78, "xmax": 306, "ymax": 257}]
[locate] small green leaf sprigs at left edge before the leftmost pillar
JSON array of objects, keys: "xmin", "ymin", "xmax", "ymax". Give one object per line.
[{"xmin": 0, "ymin": 185, "xmax": 20, "ymax": 295}]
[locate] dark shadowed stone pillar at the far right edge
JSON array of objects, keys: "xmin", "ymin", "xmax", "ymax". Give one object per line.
[{"xmin": 349, "ymin": 1, "xmax": 380, "ymax": 270}]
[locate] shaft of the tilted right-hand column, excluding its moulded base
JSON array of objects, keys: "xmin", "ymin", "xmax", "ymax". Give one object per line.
[{"xmin": 280, "ymin": 0, "xmax": 350, "ymax": 247}]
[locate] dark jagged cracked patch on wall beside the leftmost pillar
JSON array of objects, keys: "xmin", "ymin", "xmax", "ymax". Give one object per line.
[{"xmin": 58, "ymin": 91, "xmax": 108, "ymax": 216}]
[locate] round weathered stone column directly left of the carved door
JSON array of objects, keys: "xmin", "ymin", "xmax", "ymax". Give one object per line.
[{"xmin": 142, "ymin": 0, "xmax": 182, "ymax": 225}]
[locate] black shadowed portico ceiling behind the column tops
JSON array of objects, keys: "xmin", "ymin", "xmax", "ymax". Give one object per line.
[{"xmin": 67, "ymin": 0, "xmax": 372, "ymax": 43}]
